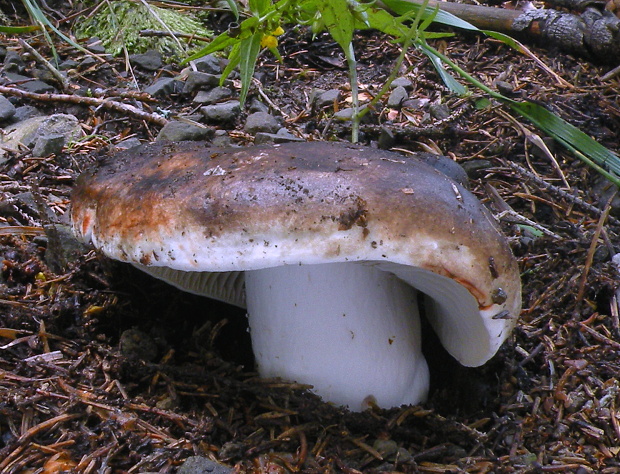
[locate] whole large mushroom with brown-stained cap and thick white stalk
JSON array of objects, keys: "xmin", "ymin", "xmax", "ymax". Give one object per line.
[{"xmin": 71, "ymin": 142, "xmax": 521, "ymax": 411}]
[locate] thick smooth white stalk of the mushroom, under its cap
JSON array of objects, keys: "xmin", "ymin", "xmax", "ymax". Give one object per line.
[{"xmin": 245, "ymin": 263, "xmax": 429, "ymax": 411}]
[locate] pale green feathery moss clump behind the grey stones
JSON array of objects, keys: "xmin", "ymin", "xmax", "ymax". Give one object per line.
[{"xmin": 74, "ymin": 1, "xmax": 211, "ymax": 59}]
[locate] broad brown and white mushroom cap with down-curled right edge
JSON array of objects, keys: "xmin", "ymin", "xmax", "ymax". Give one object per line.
[{"xmin": 71, "ymin": 142, "xmax": 521, "ymax": 365}]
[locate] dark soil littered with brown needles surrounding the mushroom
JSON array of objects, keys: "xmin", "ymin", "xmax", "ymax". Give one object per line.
[{"xmin": 0, "ymin": 1, "xmax": 620, "ymax": 473}]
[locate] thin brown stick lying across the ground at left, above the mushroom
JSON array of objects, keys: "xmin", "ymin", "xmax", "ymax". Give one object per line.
[{"xmin": 0, "ymin": 86, "xmax": 168, "ymax": 126}]
